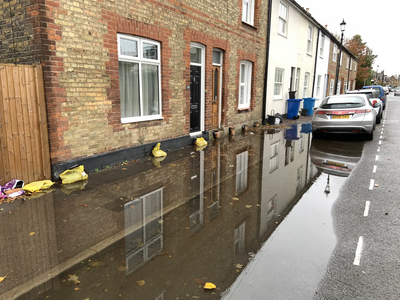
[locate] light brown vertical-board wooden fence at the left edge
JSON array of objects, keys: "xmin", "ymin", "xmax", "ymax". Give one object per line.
[{"xmin": 0, "ymin": 64, "xmax": 51, "ymax": 185}]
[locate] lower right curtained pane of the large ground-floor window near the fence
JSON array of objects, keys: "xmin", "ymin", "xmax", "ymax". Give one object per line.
[{"xmin": 142, "ymin": 64, "xmax": 160, "ymax": 116}]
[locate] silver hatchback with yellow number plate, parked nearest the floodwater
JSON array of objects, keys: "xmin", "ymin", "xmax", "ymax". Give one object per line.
[{"xmin": 311, "ymin": 94, "xmax": 379, "ymax": 140}]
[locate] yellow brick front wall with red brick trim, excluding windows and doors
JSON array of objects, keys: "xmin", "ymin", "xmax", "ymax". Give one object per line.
[{"xmin": 39, "ymin": 0, "xmax": 267, "ymax": 164}]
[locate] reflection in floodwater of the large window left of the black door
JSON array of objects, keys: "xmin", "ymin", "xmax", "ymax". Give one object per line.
[{"xmin": 124, "ymin": 188, "xmax": 163, "ymax": 274}]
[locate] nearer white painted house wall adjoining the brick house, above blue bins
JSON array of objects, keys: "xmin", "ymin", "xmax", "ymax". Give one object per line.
[{"xmin": 265, "ymin": 0, "xmax": 318, "ymax": 115}]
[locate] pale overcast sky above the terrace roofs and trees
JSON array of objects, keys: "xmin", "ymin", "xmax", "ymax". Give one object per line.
[{"xmin": 295, "ymin": 0, "xmax": 400, "ymax": 76}]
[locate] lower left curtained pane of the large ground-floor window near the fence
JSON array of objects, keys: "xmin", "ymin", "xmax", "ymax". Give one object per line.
[{"xmin": 119, "ymin": 61, "xmax": 140, "ymax": 118}]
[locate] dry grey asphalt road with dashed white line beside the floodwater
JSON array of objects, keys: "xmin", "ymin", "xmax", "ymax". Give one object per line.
[{"xmin": 314, "ymin": 94, "xmax": 400, "ymax": 299}]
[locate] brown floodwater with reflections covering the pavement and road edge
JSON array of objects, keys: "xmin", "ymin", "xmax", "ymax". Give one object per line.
[{"xmin": 0, "ymin": 124, "xmax": 362, "ymax": 300}]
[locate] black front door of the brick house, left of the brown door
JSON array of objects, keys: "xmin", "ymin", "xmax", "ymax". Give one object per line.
[{"xmin": 190, "ymin": 65, "xmax": 201, "ymax": 132}]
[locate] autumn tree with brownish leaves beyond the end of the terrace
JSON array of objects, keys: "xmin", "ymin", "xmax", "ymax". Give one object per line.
[{"xmin": 345, "ymin": 34, "xmax": 378, "ymax": 88}]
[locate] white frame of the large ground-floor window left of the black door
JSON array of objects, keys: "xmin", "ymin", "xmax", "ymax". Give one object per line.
[{"xmin": 117, "ymin": 34, "xmax": 163, "ymax": 123}]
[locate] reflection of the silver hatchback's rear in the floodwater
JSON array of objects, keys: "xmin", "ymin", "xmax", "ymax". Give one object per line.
[{"xmin": 310, "ymin": 139, "xmax": 363, "ymax": 177}]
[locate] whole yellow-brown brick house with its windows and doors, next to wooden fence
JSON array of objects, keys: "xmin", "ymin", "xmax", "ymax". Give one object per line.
[{"xmin": 0, "ymin": 0, "xmax": 268, "ymax": 177}]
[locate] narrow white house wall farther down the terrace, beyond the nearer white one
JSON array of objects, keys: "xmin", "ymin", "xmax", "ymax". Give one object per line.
[{"xmin": 314, "ymin": 32, "xmax": 331, "ymax": 107}]
